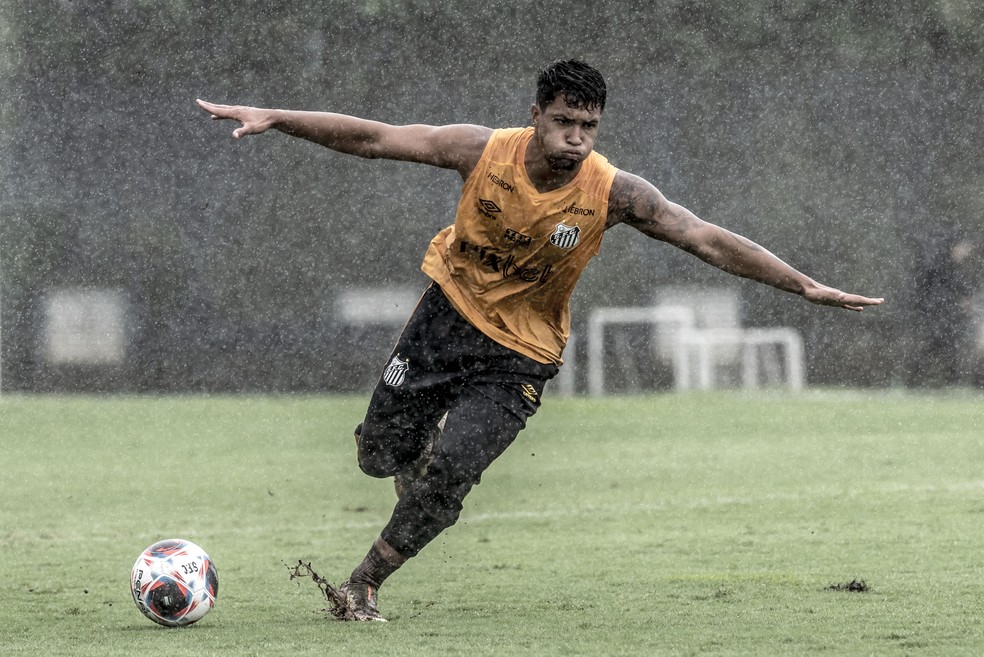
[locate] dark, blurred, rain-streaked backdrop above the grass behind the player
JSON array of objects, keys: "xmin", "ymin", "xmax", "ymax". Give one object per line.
[{"xmin": 0, "ymin": 0, "xmax": 984, "ymax": 390}]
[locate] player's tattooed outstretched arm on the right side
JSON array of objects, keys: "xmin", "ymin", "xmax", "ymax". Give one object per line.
[{"xmin": 608, "ymin": 171, "xmax": 883, "ymax": 310}]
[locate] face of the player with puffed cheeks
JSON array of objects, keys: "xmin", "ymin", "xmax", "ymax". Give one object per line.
[{"xmin": 532, "ymin": 95, "xmax": 601, "ymax": 171}]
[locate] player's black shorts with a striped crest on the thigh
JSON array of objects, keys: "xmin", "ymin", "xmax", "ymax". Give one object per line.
[{"xmin": 360, "ymin": 284, "xmax": 558, "ymax": 477}]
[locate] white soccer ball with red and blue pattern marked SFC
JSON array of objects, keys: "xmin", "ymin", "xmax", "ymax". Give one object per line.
[{"xmin": 130, "ymin": 538, "xmax": 219, "ymax": 627}]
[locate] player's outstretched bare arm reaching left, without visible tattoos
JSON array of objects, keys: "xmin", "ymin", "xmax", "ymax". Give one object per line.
[{"xmin": 196, "ymin": 100, "xmax": 492, "ymax": 177}]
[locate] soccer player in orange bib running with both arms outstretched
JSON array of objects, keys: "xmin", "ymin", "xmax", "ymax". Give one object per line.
[{"xmin": 198, "ymin": 60, "xmax": 882, "ymax": 621}]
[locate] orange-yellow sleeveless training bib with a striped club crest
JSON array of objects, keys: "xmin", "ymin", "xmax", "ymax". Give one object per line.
[{"xmin": 421, "ymin": 128, "xmax": 617, "ymax": 365}]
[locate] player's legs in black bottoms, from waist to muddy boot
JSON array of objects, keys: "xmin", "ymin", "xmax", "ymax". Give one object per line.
[{"xmin": 338, "ymin": 288, "xmax": 557, "ymax": 620}]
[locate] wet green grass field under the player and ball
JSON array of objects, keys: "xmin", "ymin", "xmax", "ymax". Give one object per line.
[{"xmin": 0, "ymin": 391, "xmax": 984, "ymax": 657}]
